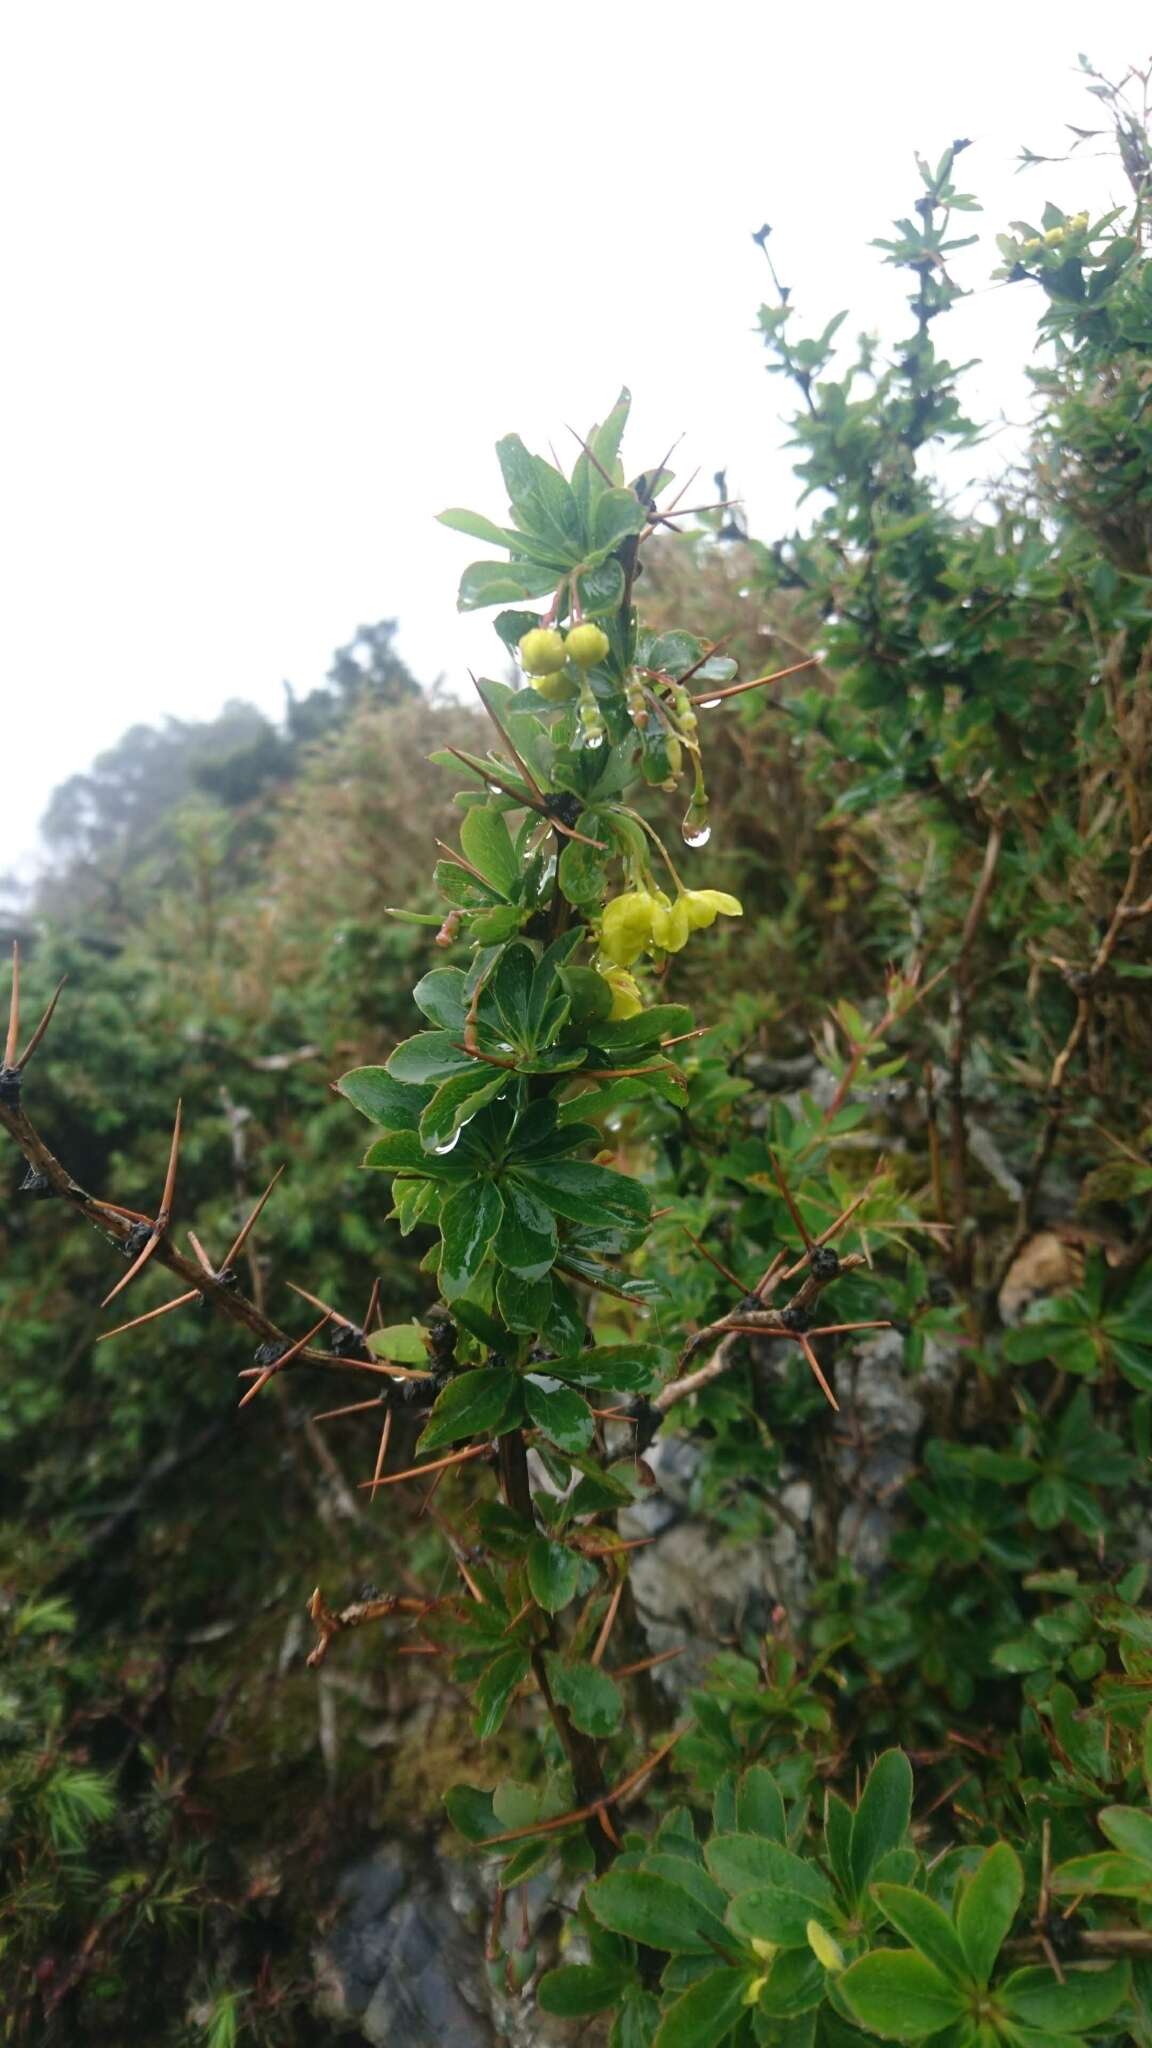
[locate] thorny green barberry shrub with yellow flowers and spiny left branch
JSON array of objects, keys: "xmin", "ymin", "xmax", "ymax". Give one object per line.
[{"xmin": 0, "ymin": 48, "xmax": 1152, "ymax": 2048}]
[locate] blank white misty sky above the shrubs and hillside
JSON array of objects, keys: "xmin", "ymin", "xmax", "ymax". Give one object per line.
[{"xmin": 0, "ymin": 0, "xmax": 1150, "ymax": 868}]
